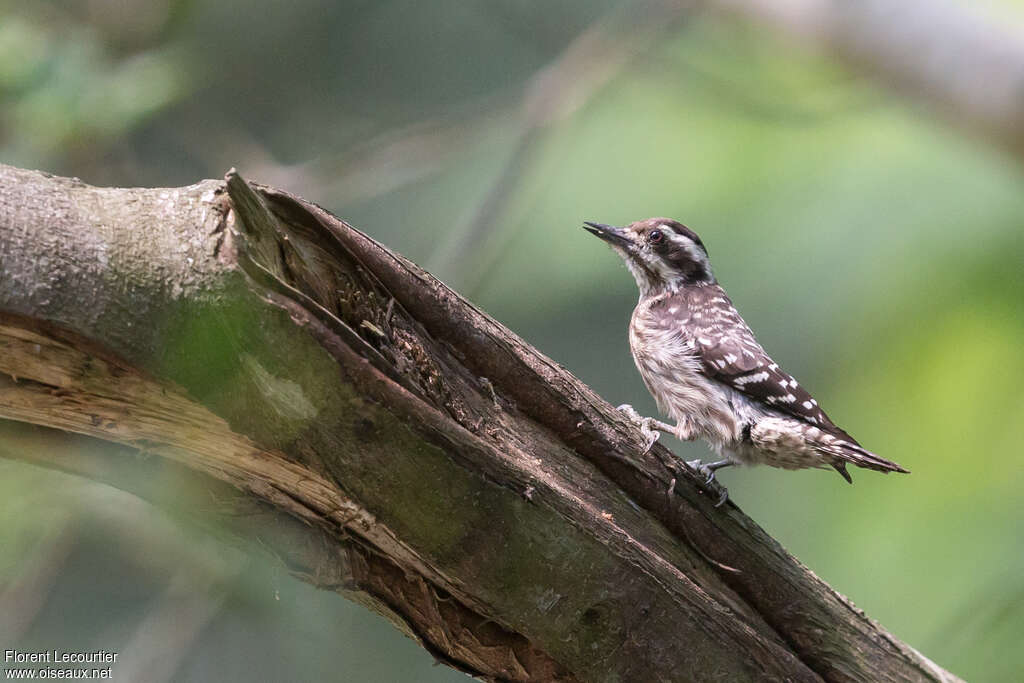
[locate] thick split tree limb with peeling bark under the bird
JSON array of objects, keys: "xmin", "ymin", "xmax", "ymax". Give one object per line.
[{"xmin": 0, "ymin": 167, "xmax": 957, "ymax": 681}]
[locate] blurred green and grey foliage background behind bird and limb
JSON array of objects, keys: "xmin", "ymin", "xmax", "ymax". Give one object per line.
[{"xmin": 0, "ymin": 0, "xmax": 1024, "ymax": 681}]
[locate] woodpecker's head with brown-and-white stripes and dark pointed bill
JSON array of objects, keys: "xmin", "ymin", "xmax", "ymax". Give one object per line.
[{"xmin": 584, "ymin": 218, "xmax": 715, "ymax": 296}]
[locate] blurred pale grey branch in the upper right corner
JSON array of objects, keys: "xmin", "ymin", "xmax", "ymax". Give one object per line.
[{"xmin": 709, "ymin": 0, "xmax": 1024, "ymax": 160}]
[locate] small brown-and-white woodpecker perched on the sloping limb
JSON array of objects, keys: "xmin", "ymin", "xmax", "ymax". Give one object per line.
[{"xmin": 584, "ymin": 218, "xmax": 907, "ymax": 504}]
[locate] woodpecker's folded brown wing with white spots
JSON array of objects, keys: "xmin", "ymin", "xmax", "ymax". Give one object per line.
[{"xmin": 667, "ymin": 286, "xmax": 857, "ymax": 444}]
